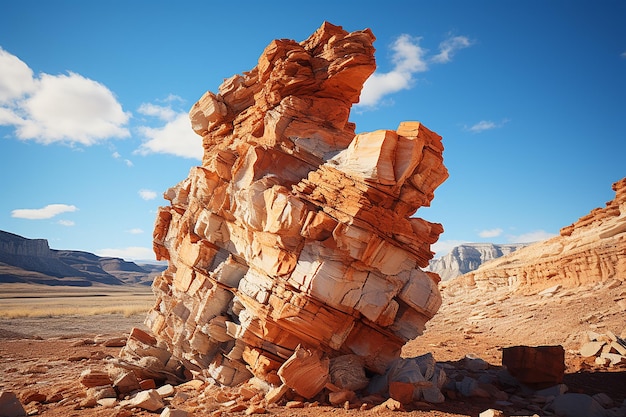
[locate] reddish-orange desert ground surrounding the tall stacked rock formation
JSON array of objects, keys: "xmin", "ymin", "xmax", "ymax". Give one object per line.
[{"xmin": 0, "ymin": 281, "xmax": 626, "ymax": 417}]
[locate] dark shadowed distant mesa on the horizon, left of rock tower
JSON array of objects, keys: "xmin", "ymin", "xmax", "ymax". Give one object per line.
[{"xmin": 0, "ymin": 230, "xmax": 165, "ymax": 286}]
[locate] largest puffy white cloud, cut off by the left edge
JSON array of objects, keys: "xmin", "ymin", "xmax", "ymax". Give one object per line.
[{"xmin": 0, "ymin": 49, "xmax": 130, "ymax": 146}]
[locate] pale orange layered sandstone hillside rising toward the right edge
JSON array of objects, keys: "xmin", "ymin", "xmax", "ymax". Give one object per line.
[{"xmin": 458, "ymin": 178, "xmax": 626, "ymax": 292}]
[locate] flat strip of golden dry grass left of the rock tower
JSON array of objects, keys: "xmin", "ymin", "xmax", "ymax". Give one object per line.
[{"xmin": 0, "ymin": 284, "xmax": 154, "ymax": 319}]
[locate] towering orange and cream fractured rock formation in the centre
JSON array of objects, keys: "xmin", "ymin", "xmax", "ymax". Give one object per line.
[{"xmin": 146, "ymin": 23, "xmax": 448, "ymax": 385}]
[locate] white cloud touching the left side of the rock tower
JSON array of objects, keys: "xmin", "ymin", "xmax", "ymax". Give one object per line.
[{"xmin": 137, "ymin": 112, "xmax": 203, "ymax": 160}]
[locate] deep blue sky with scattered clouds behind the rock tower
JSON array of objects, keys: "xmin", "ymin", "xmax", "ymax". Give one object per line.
[{"xmin": 0, "ymin": 0, "xmax": 626, "ymax": 260}]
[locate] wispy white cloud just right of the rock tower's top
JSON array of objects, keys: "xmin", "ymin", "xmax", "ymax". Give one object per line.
[{"xmin": 357, "ymin": 34, "xmax": 471, "ymax": 107}]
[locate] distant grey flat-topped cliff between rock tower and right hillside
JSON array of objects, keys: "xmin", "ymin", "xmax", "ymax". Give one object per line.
[{"xmin": 425, "ymin": 243, "xmax": 528, "ymax": 281}]
